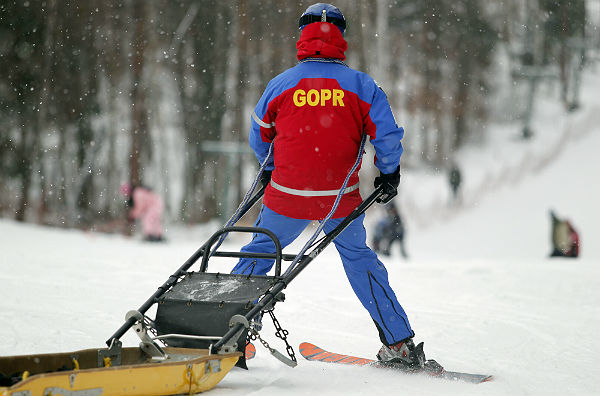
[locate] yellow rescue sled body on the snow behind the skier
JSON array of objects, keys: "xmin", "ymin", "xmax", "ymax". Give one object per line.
[{"xmin": 0, "ymin": 344, "xmax": 241, "ymax": 396}]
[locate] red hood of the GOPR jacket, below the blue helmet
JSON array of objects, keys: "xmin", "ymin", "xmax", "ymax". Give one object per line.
[{"xmin": 296, "ymin": 22, "xmax": 348, "ymax": 60}]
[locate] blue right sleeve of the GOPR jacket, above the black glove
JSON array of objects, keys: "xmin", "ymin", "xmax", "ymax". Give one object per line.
[{"xmin": 369, "ymin": 87, "xmax": 404, "ymax": 174}]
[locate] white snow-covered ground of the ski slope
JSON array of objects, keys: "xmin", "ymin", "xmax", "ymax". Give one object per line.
[{"xmin": 0, "ymin": 73, "xmax": 600, "ymax": 395}]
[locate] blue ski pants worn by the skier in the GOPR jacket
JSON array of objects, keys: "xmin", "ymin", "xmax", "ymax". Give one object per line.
[{"xmin": 232, "ymin": 205, "xmax": 414, "ymax": 345}]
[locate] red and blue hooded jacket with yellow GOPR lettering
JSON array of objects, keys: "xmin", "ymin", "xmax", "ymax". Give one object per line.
[{"xmin": 250, "ymin": 22, "xmax": 404, "ymax": 220}]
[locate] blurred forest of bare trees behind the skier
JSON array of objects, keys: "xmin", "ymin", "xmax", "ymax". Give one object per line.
[{"xmin": 0, "ymin": 0, "xmax": 600, "ymax": 228}]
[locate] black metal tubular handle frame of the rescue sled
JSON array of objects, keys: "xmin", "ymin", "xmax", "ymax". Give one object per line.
[{"xmin": 106, "ymin": 185, "xmax": 385, "ymax": 354}]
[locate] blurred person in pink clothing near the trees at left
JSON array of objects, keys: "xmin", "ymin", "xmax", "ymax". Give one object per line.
[{"xmin": 121, "ymin": 183, "xmax": 164, "ymax": 242}]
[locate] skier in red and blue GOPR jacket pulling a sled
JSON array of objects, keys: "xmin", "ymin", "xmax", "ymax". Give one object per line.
[{"xmin": 233, "ymin": 3, "xmax": 425, "ymax": 369}]
